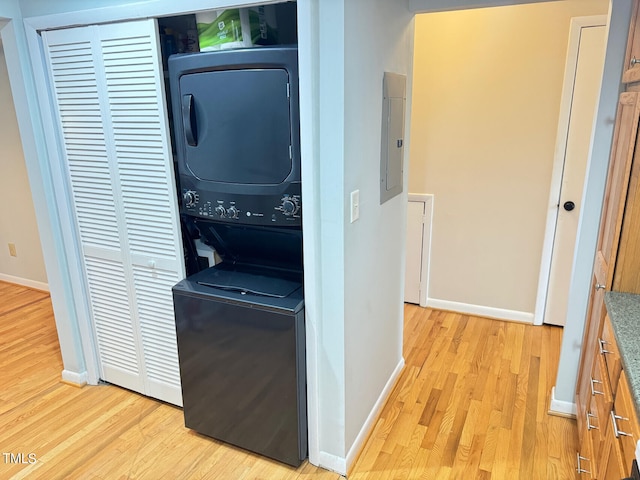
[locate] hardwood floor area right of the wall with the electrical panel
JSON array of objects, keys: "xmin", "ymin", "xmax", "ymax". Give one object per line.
[{"xmin": 349, "ymin": 305, "xmax": 578, "ymax": 480}]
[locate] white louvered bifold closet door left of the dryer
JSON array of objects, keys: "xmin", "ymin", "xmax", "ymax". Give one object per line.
[{"xmin": 42, "ymin": 20, "xmax": 184, "ymax": 405}]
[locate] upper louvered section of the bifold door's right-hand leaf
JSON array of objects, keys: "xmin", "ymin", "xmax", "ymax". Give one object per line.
[{"xmin": 102, "ymin": 25, "xmax": 184, "ymax": 266}]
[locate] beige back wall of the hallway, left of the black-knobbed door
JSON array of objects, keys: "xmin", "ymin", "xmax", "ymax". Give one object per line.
[{"xmin": 409, "ymin": 0, "xmax": 609, "ymax": 321}]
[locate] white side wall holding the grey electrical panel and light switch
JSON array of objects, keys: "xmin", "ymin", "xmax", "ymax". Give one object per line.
[{"xmin": 339, "ymin": 0, "xmax": 413, "ymax": 462}]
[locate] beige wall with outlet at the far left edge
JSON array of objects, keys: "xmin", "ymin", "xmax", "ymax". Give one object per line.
[{"xmin": 0, "ymin": 44, "xmax": 48, "ymax": 289}]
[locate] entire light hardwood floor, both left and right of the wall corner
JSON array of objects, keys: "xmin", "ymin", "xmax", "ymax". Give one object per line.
[{"xmin": 0, "ymin": 282, "xmax": 577, "ymax": 480}]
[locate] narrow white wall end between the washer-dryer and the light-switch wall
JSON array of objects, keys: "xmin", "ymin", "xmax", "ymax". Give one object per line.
[{"xmin": 314, "ymin": 0, "xmax": 347, "ymax": 464}]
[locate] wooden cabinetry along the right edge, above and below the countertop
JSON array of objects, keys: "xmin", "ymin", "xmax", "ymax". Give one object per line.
[{"xmin": 576, "ymin": 5, "xmax": 640, "ymax": 474}]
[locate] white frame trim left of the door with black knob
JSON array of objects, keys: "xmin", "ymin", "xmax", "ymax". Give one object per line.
[{"xmin": 533, "ymin": 15, "xmax": 607, "ymax": 325}]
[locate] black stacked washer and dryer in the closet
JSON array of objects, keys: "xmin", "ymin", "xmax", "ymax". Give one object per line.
[{"xmin": 169, "ymin": 47, "xmax": 307, "ymax": 466}]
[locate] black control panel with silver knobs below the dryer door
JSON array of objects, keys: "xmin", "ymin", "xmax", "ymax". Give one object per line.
[{"xmin": 182, "ymin": 189, "xmax": 302, "ymax": 226}]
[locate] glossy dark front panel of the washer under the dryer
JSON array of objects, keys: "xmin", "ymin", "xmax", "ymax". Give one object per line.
[{"xmin": 174, "ymin": 291, "xmax": 307, "ymax": 466}]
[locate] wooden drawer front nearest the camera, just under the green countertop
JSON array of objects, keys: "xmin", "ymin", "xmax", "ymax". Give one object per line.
[{"xmin": 610, "ymin": 371, "xmax": 640, "ymax": 476}]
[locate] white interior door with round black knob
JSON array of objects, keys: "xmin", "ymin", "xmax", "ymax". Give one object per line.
[{"xmin": 544, "ymin": 25, "xmax": 606, "ymax": 325}]
